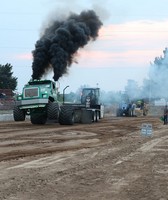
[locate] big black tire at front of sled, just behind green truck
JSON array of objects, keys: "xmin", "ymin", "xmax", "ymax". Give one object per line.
[{"xmin": 59, "ymin": 106, "xmax": 74, "ymax": 125}]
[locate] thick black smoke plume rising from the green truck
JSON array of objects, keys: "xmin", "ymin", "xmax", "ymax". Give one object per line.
[{"xmin": 32, "ymin": 10, "xmax": 102, "ymax": 81}]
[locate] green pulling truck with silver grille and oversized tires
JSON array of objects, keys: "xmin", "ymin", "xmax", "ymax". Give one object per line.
[{"xmin": 13, "ymin": 80, "xmax": 60, "ymax": 124}]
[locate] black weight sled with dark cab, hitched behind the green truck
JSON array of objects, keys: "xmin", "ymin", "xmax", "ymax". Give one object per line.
[{"xmin": 59, "ymin": 88, "xmax": 104, "ymax": 125}]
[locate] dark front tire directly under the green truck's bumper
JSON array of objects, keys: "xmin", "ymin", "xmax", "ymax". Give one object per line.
[{"xmin": 30, "ymin": 113, "xmax": 47, "ymax": 124}]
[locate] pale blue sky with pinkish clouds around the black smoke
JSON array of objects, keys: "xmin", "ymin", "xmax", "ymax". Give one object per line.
[{"xmin": 0, "ymin": 0, "xmax": 168, "ymax": 92}]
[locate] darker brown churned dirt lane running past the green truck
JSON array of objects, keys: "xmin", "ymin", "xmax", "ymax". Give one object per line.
[{"xmin": 0, "ymin": 115, "xmax": 163, "ymax": 161}]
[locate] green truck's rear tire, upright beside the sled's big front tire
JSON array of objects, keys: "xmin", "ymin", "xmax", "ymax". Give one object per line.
[{"xmin": 47, "ymin": 102, "xmax": 59, "ymax": 120}]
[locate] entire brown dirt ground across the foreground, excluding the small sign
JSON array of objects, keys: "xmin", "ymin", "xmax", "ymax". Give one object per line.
[{"xmin": 0, "ymin": 116, "xmax": 168, "ymax": 200}]
